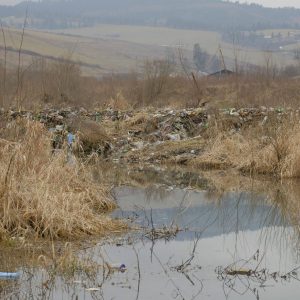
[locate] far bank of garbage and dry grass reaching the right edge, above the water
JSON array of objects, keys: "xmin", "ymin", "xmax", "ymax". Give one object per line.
[{"xmin": 4, "ymin": 103, "xmax": 300, "ymax": 178}]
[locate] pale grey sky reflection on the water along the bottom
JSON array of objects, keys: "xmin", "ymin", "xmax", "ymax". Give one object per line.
[{"xmin": 17, "ymin": 229, "xmax": 300, "ymax": 300}]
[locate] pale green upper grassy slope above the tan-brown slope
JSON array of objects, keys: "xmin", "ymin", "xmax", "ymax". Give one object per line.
[{"xmin": 53, "ymin": 24, "xmax": 290, "ymax": 64}]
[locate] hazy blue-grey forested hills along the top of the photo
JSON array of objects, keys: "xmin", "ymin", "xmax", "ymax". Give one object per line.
[{"xmin": 0, "ymin": 0, "xmax": 300, "ymax": 32}]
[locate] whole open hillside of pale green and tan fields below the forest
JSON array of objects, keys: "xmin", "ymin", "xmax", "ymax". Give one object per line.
[{"xmin": 0, "ymin": 24, "xmax": 291, "ymax": 76}]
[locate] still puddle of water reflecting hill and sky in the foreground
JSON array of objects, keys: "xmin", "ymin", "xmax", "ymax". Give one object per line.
[{"xmin": 1, "ymin": 170, "xmax": 300, "ymax": 300}]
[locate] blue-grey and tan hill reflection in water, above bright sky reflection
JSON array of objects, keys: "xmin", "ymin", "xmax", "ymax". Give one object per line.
[{"xmin": 114, "ymin": 187, "xmax": 287, "ymax": 239}]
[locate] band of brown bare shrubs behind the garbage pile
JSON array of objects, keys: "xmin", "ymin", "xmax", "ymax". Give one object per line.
[{"xmin": 0, "ymin": 55, "xmax": 299, "ymax": 110}]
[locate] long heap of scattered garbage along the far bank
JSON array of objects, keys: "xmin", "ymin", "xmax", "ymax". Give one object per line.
[{"xmin": 0, "ymin": 107, "xmax": 299, "ymax": 159}]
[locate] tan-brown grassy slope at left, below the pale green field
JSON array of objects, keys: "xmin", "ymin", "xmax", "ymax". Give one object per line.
[{"xmin": 0, "ymin": 29, "xmax": 164, "ymax": 75}]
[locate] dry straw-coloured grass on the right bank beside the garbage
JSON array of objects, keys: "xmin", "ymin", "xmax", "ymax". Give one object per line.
[{"xmin": 116, "ymin": 106, "xmax": 300, "ymax": 178}]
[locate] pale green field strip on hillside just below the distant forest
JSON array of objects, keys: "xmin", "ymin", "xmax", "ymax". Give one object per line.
[{"xmin": 54, "ymin": 24, "xmax": 293, "ymax": 67}]
